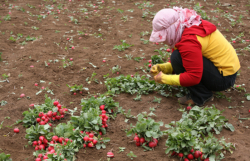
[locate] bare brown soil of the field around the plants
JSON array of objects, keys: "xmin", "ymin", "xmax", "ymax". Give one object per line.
[{"xmin": 0, "ymin": 0, "xmax": 250, "ymax": 161}]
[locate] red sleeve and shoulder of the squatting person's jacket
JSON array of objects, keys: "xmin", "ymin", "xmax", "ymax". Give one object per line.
[{"xmin": 175, "ymin": 20, "xmax": 216, "ymax": 87}]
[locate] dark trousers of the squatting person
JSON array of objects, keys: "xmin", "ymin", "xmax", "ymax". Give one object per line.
[{"xmin": 170, "ymin": 50, "xmax": 237, "ymax": 106}]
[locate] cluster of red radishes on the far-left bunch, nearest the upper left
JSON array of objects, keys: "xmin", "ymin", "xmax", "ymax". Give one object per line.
[{"xmin": 36, "ymin": 101, "xmax": 68, "ymax": 126}]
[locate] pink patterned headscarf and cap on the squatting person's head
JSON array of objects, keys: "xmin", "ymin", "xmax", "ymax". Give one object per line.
[{"xmin": 149, "ymin": 7, "xmax": 201, "ymax": 48}]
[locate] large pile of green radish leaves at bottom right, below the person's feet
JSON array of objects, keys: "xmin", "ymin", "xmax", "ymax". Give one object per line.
[{"xmin": 164, "ymin": 106, "xmax": 234, "ymax": 160}]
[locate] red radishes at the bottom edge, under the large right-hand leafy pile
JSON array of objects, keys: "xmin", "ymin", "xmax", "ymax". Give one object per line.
[{"xmin": 172, "ymin": 149, "xmax": 209, "ymax": 161}]
